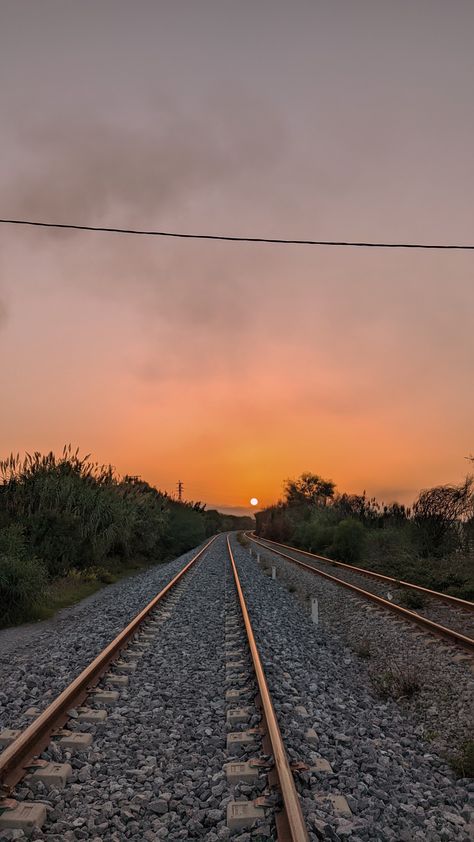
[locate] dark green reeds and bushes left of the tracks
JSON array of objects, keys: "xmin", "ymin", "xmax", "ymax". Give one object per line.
[{"xmin": 0, "ymin": 446, "xmax": 253, "ymax": 626}]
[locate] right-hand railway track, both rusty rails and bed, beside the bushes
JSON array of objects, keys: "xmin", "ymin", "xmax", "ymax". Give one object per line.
[{"xmin": 246, "ymin": 533, "xmax": 474, "ymax": 655}]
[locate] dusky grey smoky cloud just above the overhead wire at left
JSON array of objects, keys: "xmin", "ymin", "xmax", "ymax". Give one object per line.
[{"xmin": 2, "ymin": 100, "xmax": 283, "ymax": 226}]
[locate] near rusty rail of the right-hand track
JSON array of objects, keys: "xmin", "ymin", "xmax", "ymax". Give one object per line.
[{"xmin": 247, "ymin": 533, "xmax": 474, "ymax": 654}]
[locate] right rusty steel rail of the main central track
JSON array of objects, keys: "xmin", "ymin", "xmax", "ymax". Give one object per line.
[{"xmin": 227, "ymin": 536, "xmax": 309, "ymax": 842}]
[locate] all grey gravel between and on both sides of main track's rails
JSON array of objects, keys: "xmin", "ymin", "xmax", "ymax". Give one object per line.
[{"xmin": 0, "ymin": 536, "xmax": 474, "ymax": 842}]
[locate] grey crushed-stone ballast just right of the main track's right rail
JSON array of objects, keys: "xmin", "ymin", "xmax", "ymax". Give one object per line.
[{"xmin": 233, "ymin": 541, "xmax": 474, "ymax": 842}]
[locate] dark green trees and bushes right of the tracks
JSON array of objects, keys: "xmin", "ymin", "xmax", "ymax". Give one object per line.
[{"xmin": 256, "ymin": 473, "xmax": 474, "ymax": 599}]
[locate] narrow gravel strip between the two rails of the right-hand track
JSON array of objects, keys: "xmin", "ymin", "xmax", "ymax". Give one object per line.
[{"xmin": 254, "ymin": 545, "xmax": 474, "ymax": 639}]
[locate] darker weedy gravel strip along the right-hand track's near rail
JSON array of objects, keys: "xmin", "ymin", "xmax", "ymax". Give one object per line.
[{"xmin": 250, "ymin": 546, "xmax": 474, "ymax": 757}]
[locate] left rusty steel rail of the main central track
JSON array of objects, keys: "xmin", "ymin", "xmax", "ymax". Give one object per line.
[{"xmin": 0, "ymin": 536, "xmax": 217, "ymax": 799}]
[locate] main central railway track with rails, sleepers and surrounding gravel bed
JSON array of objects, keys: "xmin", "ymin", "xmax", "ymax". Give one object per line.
[{"xmin": 0, "ymin": 536, "xmax": 468, "ymax": 842}]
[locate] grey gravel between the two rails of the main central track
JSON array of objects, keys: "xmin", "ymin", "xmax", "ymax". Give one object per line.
[{"xmin": 0, "ymin": 537, "xmax": 278, "ymax": 842}]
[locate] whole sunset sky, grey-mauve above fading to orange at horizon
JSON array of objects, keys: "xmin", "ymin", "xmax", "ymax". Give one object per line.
[{"xmin": 0, "ymin": 0, "xmax": 474, "ymax": 512}]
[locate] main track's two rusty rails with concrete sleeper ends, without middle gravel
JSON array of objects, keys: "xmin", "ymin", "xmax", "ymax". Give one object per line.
[{"xmin": 0, "ymin": 538, "xmax": 310, "ymax": 842}]
